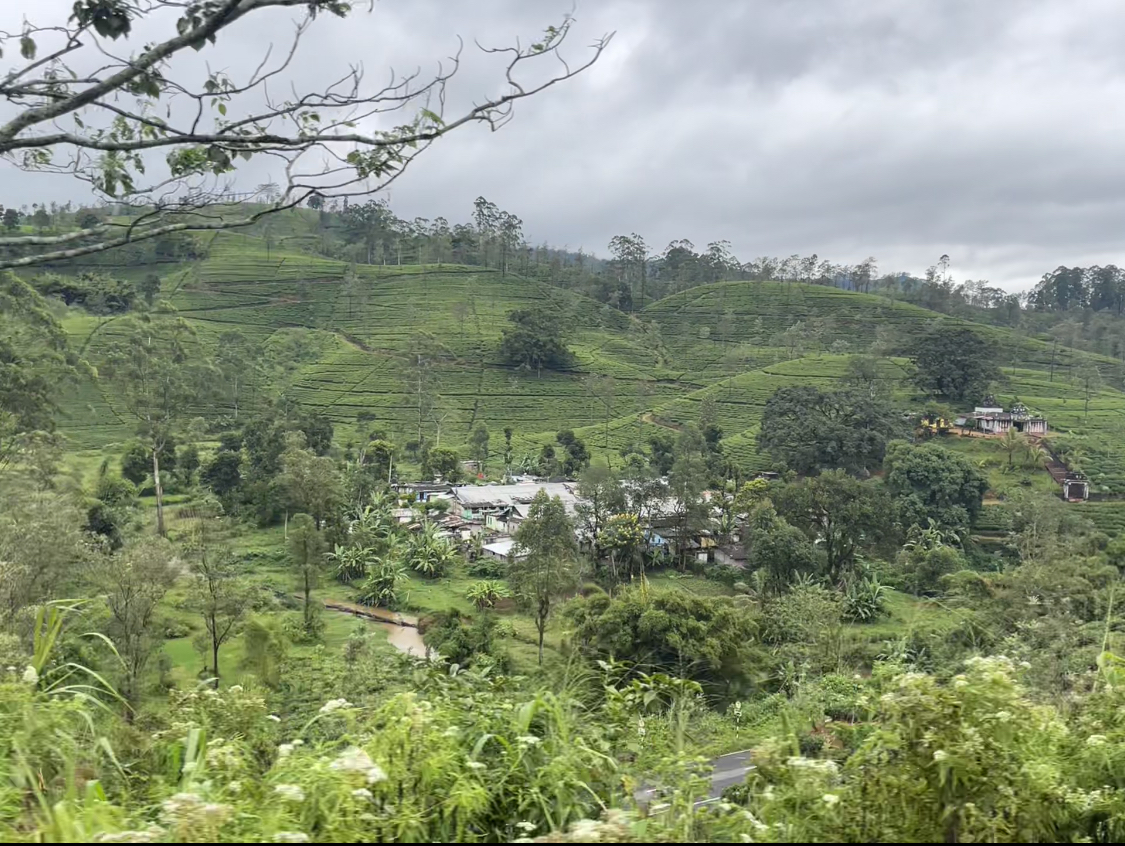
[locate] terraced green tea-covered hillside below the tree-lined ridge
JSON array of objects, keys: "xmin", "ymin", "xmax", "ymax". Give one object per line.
[{"xmin": 52, "ymin": 233, "xmax": 1125, "ymax": 493}]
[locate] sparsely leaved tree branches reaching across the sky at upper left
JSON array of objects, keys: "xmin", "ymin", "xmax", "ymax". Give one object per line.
[{"xmin": 0, "ymin": 0, "xmax": 612, "ymax": 269}]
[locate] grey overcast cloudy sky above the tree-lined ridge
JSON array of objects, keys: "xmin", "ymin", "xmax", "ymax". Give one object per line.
[{"xmin": 0, "ymin": 0, "xmax": 1125, "ymax": 288}]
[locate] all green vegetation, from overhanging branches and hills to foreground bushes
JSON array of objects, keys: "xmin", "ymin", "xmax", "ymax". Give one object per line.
[{"xmin": 0, "ymin": 0, "xmax": 1125, "ymax": 843}]
